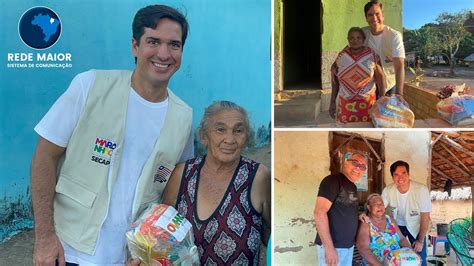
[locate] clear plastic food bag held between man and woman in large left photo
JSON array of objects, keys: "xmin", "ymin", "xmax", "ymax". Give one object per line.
[{"xmin": 126, "ymin": 204, "xmax": 199, "ymax": 265}]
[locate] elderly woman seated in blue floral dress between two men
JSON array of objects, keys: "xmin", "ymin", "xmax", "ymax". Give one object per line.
[{"xmin": 356, "ymin": 193, "xmax": 410, "ymax": 265}]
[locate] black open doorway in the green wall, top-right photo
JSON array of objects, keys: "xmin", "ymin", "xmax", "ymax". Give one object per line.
[{"xmin": 282, "ymin": 0, "xmax": 321, "ymax": 90}]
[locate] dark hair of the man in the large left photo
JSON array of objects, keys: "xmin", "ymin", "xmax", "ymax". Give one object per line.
[{"xmin": 132, "ymin": 5, "xmax": 189, "ymax": 49}]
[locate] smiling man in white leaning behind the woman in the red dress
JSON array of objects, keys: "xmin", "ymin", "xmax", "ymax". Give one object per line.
[{"xmin": 363, "ymin": 0, "xmax": 405, "ymax": 95}]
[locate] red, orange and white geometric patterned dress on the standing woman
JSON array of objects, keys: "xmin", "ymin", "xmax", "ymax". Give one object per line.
[{"xmin": 336, "ymin": 47, "xmax": 378, "ymax": 123}]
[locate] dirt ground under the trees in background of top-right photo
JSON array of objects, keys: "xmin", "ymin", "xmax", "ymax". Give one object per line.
[{"xmin": 405, "ymin": 66, "xmax": 474, "ymax": 95}]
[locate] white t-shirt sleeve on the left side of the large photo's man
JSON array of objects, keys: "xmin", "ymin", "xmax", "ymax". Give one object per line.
[{"xmin": 35, "ymin": 70, "xmax": 95, "ymax": 148}]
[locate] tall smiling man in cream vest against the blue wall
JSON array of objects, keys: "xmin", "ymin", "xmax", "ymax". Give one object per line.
[{"xmin": 31, "ymin": 5, "xmax": 194, "ymax": 266}]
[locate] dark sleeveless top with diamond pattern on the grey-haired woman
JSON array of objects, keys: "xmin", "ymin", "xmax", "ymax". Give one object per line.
[{"xmin": 176, "ymin": 157, "xmax": 263, "ymax": 265}]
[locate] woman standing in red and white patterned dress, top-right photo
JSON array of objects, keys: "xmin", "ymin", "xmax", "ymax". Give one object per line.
[{"xmin": 329, "ymin": 27, "xmax": 385, "ymax": 123}]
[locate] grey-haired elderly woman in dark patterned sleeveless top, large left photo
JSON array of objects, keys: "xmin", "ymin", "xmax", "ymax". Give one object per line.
[{"xmin": 163, "ymin": 101, "xmax": 271, "ymax": 265}]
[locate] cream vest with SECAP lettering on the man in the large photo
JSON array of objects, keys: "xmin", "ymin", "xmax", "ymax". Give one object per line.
[{"xmin": 54, "ymin": 70, "xmax": 192, "ymax": 255}]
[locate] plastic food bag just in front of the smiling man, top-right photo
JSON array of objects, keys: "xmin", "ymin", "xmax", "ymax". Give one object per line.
[{"xmin": 369, "ymin": 95, "xmax": 415, "ymax": 128}]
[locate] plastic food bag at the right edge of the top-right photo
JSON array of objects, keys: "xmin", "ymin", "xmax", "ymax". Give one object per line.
[{"xmin": 436, "ymin": 95, "xmax": 474, "ymax": 126}]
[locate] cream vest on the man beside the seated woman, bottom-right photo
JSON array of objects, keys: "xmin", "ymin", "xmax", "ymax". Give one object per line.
[{"xmin": 385, "ymin": 180, "xmax": 425, "ymax": 238}]
